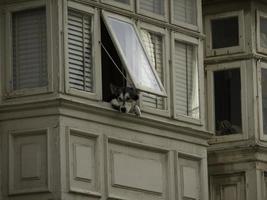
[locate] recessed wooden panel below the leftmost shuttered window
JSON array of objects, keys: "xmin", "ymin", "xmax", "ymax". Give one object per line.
[{"xmin": 9, "ymin": 130, "xmax": 49, "ymax": 194}]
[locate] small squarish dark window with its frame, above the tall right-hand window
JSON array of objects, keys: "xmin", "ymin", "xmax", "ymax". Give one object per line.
[{"xmin": 205, "ymin": 11, "xmax": 244, "ymax": 56}]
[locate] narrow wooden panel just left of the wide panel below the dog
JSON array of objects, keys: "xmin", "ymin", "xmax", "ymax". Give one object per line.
[{"xmin": 69, "ymin": 130, "xmax": 99, "ymax": 195}]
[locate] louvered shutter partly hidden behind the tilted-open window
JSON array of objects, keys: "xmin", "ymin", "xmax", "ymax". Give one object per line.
[{"xmin": 141, "ymin": 29, "xmax": 165, "ymax": 110}]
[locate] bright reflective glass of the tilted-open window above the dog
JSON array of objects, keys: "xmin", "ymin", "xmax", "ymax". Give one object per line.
[{"xmin": 107, "ymin": 17, "xmax": 163, "ymax": 94}]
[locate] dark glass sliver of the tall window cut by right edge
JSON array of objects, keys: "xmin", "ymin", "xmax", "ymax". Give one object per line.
[{"xmin": 261, "ymin": 69, "xmax": 267, "ymax": 134}]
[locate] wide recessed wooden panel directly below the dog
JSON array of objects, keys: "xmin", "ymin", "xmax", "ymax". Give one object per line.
[{"xmin": 107, "ymin": 141, "xmax": 168, "ymax": 200}]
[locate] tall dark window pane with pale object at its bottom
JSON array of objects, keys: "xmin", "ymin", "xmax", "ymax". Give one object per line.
[{"xmin": 214, "ymin": 68, "xmax": 242, "ymax": 135}]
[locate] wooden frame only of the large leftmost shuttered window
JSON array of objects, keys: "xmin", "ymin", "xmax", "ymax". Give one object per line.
[{"xmin": 5, "ymin": 0, "xmax": 54, "ymax": 98}]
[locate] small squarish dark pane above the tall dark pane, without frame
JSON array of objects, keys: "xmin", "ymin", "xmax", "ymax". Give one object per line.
[{"xmin": 211, "ymin": 16, "xmax": 239, "ymax": 49}]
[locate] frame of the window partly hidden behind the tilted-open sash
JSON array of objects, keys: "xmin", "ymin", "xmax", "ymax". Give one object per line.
[{"xmin": 138, "ymin": 22, "xmax": 170, "ymax": 116}]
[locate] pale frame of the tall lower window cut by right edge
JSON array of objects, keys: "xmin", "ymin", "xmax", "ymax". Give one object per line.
[{"xmin": 257, "ymin": 62, "xmax": 267, "ymax": 140}]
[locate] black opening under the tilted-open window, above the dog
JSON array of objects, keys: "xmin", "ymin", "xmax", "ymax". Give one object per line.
[{"xmin": 101, "ymin": 20, "xmax": 126, "ymax": 102}]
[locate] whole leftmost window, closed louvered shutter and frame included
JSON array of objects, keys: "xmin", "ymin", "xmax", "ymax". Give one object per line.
[{"xmin": 5, "ymin": 1, "xmax": 52, "ymax": 97}]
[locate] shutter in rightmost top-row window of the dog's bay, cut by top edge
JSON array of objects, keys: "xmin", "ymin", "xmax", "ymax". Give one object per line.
[{"xmin": 173, "ymin": 0, "xmax": 197, "ymax": 25}]
